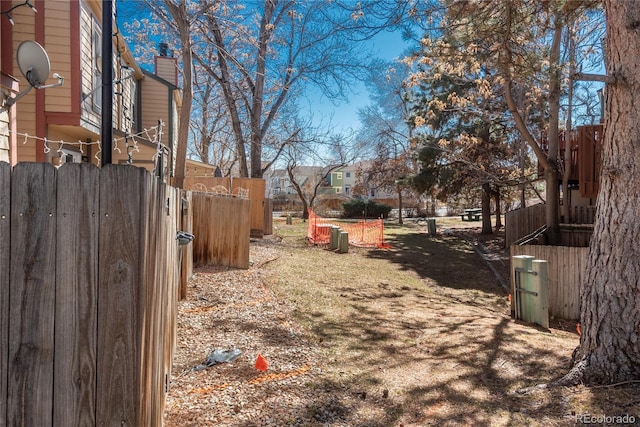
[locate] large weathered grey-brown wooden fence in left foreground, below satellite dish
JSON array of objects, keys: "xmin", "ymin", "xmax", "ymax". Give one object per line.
[{"xmin": 0, "ymin": 163, "xmax": 181, "ymax": 427}]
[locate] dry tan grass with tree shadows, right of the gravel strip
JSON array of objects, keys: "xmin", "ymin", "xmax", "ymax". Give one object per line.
[{"xmin": 264, "ymin": 219, "xmax": 639, "ymax": 426}]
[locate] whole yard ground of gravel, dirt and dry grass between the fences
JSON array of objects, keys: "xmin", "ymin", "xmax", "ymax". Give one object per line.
[{"xmin": 165, "ymin": 219, "xmax": 640, "ymax": 427}]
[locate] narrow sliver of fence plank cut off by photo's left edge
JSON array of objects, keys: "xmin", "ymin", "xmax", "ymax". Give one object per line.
[{"xmin": 0, "ymin": 162, "xmax": 11, "ymax": 426}]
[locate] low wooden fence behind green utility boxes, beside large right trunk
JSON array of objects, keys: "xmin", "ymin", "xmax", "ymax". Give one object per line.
[{"xmin": 510, "ymin": 245, "xmax": 589, "ymax": 320}]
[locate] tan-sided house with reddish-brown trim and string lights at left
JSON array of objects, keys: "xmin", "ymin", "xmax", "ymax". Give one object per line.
[{"xmin": 0, "ymin": 0, "xmax": 181, "ymax": 181}]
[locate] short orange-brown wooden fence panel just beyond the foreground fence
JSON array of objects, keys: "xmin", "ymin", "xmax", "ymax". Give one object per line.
[{"xmin": 192, "ymin": 191, "xmax": 251, "ymax": 268}]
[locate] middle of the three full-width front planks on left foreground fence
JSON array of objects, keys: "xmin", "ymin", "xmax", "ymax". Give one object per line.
[{"xmin": 53, "ymin": 163, "xmax": 99, "ymax": 427}]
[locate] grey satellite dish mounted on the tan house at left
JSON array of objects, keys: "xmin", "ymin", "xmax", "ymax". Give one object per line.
[{"xmin": 6, "ymin": 40, "xmax": 64, "ymax": 107}]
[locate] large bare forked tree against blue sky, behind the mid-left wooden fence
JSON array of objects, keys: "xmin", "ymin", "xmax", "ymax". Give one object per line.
[{"xmin": 196, "ymin": 0, "xmax": 408, "ymax": 177}]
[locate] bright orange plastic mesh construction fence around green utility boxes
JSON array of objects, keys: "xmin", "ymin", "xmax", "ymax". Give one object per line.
[{"xmin": 307, "ymin": 209, "xmax": 388, "ymax": 248}]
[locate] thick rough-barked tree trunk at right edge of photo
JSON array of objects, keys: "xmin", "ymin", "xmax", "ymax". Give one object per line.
[{"xmin": 559, "ymin": 0, "xmax": 640, "ymax": 384}]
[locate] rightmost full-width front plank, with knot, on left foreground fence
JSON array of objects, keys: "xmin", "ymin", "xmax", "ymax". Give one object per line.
[{"xmin": 96, "ymin": 165, "xmax": 146, "ymax": 425}]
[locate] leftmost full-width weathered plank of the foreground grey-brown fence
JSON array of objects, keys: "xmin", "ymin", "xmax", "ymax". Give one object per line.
[{"xmin": 7, "ymin": 163, "xmax": 56, "ymax": 426}]
